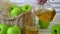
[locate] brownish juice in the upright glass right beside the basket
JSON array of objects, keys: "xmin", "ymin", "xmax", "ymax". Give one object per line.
[{"xmin": 23, "ymin": 12, "xmax": 34, "ymax": 26}]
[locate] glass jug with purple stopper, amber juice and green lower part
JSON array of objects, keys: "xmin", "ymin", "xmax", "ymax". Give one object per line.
[{"xmin": 35, "ymin": 0, "xmax": 56, "ymax": 29}]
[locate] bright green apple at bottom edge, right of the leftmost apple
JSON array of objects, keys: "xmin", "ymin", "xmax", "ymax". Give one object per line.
[{"xmin": 7, "ymin": 25, "xmax": 21, "ymax": 34}]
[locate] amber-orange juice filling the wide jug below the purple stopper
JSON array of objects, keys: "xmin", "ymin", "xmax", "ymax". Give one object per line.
[{"xmin": 35, "ymin": 9, "xmax": 56, "ymax": 22}]
